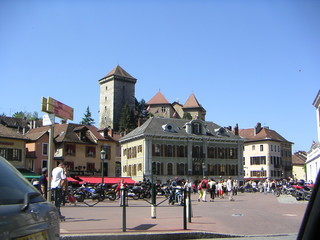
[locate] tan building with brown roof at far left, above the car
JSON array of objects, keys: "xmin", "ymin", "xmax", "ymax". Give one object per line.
[{"xmin": 0, "ymin": 124, "xmax": 28, "ymax": 169}]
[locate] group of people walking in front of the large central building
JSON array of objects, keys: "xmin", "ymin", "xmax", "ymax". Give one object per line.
[{"xmin": 194, "ymin": 177, "xmax": 238, "ymax": 202}]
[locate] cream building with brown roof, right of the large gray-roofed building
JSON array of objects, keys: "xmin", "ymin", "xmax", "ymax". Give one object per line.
[{"xmin": 239, "ymin": 123, "xmax": 293, "ymax": 180}]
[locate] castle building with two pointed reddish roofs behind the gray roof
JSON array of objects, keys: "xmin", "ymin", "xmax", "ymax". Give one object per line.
[{"xmin": 147, "ymin": 91, "xmax": 206, "ymax": 121}]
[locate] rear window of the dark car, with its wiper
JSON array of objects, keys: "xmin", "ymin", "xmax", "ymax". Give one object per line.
[{"xmin": 0, "ymin": 157, "xmax": 45, "ymax": 205}]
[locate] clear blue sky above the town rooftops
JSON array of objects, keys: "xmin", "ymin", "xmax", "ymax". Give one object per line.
[{"xmin": 0, "ymin": 0, "xmax": 320, "ymax": 152}]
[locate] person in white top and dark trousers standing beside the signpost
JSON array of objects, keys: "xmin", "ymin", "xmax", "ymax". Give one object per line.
[{"xmin": 51, "ymin": 163, "xmax": 67, "ymax": 218}]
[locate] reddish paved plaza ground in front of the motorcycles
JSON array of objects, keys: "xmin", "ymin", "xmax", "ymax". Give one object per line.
[{"xmin": 60, "ymin": 193, "xmax": 308, "ymax": 239}]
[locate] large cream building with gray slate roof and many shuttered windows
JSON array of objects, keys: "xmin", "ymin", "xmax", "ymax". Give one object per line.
[{"xmin": 120, "ymin": 117, "xmax": 244, "ymax": 182}]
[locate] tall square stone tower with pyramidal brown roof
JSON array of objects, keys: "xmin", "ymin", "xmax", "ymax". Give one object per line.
[{"xmin": 99, "ymin": 65, "xmax": 137, "ymax": 131}]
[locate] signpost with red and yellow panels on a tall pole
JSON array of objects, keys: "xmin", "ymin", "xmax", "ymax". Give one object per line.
[{"xmin": 41, "ymin": 97, "xmax": 73, "ymax": 202}]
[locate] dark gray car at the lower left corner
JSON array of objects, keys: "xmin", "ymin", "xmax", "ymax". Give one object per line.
[{"xmin": 0, "ymin": 157, "xmax": 60, "ymax": 240}]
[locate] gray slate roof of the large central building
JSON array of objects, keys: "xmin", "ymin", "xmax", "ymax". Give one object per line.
[{"xmin": 120, "ymin": 118, "xmax": 243, "ymax": 142}]
